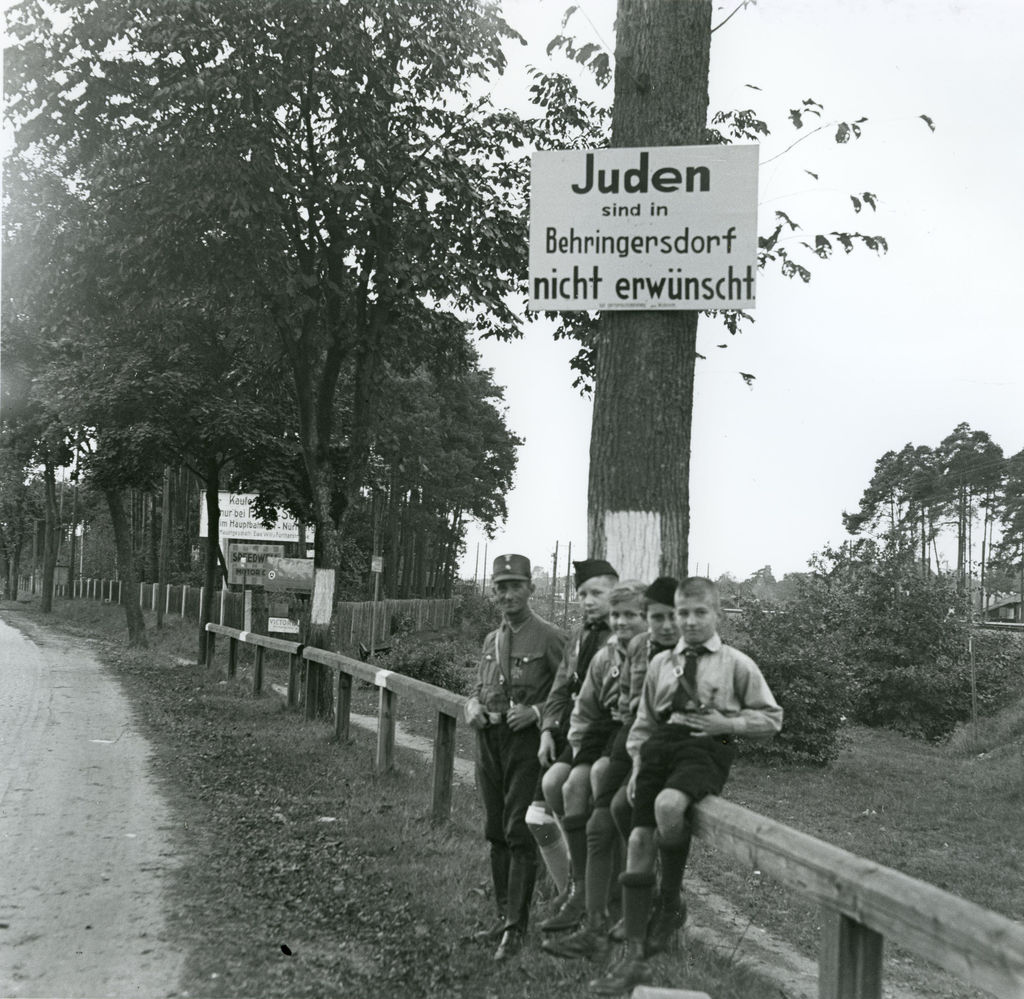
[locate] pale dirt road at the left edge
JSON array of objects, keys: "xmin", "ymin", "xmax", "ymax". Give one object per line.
[{"xmin": 0, "ymin": 621, "xmax": 183, "ymax": 997}]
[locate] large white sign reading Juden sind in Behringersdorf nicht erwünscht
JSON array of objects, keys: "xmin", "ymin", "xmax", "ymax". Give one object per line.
[{"xmin": 529, "ymin": 145, "xmax": 759, "ymax": 311}]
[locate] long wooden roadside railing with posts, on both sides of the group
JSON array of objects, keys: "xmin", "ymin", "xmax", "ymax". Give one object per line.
[{"xmin": 201, "ymin": 624, "xmax": 1024, "ymax": 999}]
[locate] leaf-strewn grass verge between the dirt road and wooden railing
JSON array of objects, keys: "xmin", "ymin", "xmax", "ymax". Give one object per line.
[{"xmin": 0, "ymin": 601, "xmax": 768, "ymax": 999}]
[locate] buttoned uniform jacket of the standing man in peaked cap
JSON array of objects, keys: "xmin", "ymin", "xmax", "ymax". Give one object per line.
[{"xmin": 472, "ymin": 613, "xmax": 567, "ymax": 712}]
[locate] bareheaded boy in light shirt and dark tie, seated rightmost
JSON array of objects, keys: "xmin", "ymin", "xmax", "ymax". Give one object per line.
[{"xmin": 590, "ymin": 576, "xmax": 782, "ymax": 996}]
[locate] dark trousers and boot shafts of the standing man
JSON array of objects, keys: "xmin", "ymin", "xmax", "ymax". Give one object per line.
[{"xmin": 476, "ymin": 722, "xmax": 541, "ymax": 930}]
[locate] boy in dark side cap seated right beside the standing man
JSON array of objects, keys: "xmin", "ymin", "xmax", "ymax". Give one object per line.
[{"xmin": 530, "ymin": 559, "xmax": 618, "ymax": 929}]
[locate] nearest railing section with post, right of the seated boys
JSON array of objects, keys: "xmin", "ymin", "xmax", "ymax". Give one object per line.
[{"xmin": 694, "ymin": 797, "xmax": 1024, "ymax": 999}]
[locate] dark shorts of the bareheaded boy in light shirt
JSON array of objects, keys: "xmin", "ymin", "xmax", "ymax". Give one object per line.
[{"xmin": 633, "ymin": 725, "xmax": 736, "ymax": 828}]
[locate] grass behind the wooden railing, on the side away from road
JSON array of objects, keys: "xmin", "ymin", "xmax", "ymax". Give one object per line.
[{"xmin": 193, "ymin": 605, "xmax": 1024, "ymax": 999}]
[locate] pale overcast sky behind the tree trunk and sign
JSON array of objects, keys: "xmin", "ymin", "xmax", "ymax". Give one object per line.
[{"xmin": 463, "ymin": 0, "xmax": 1024, "ymax": 579}]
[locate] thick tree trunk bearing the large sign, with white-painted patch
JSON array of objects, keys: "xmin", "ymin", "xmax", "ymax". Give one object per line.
[{"xmin": 588, "ymin": 0, "xmax": 712, "ymax": 579}]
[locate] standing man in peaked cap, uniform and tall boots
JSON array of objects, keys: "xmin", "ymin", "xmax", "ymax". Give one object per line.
[{"xmin": 465, "ymin": 555, "xmax": 566, "ymax": 961}]
